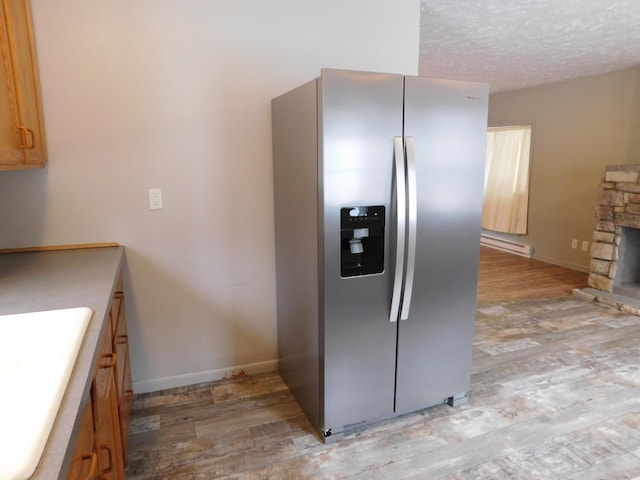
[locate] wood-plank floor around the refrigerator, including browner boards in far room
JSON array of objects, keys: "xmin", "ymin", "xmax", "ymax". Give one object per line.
[{"xmin": 127, "ymin": 250, "xmax": 640, "ymax": 480}]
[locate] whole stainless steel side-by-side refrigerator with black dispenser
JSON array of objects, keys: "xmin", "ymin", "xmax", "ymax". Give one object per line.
[{"xmin": 271, "ymin": 69, "xmax": 488, "ymax": 441}]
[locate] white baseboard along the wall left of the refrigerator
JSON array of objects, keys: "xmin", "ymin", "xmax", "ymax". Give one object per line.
[{"xmin": 133, "ymin": 360, "xmax": 278, "ymax": 393}]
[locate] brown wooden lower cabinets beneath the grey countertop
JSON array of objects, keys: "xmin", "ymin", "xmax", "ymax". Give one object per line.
[{"xmin": 67, "ymin": 278, "xmax": 133, "ymax": 480}]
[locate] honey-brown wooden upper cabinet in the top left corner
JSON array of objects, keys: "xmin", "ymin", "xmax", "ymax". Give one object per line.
[{"xmin": 0, "ymin": 0, "xmax": 47, "ymax": 170}]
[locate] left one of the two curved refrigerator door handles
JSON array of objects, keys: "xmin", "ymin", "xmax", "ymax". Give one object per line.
[{"xmin": 389, "ymin": 137, "xmax": 407, "ymax": 322}]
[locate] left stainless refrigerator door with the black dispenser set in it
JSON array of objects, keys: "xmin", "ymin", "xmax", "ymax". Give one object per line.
[{"xmin": 320, "ymin": 69, "xmax": 403, "ymax": 433}]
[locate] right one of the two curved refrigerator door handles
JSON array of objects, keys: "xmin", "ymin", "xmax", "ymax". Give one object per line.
[{"xmin": 400, "ymin": 137, "xmax": 418, "ymax": 320}]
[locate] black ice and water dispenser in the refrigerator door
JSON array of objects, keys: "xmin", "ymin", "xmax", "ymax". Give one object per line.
[{"xmin": 340, "ymin": 206, "xmax": 384, "ymax": 277}]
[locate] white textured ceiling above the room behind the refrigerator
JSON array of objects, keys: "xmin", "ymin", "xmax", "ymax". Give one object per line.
[{"xmin": 419, "ymin": 0, "xmax": 640, "ymax": 92}]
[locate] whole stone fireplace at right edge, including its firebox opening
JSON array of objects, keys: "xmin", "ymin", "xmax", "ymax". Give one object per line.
[{"xmin": 589, "ymin": 165, "xmax": 640, "ymax": 303}]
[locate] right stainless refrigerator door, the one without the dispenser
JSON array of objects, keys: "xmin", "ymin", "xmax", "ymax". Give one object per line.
[{"xmin": 396, "ymin": 77, "xmax": 488, "ymax": 412}]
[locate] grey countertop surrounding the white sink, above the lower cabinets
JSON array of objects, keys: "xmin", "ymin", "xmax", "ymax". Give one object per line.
[{"xmin": 0, "ymin": 246, "xmax": 124, "ymax": 480}]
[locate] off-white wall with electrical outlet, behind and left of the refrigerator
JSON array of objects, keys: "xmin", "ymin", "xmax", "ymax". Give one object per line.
[{"xmin": 0, "ymin": 0, "xmax": 420, "ymax": 392}]
